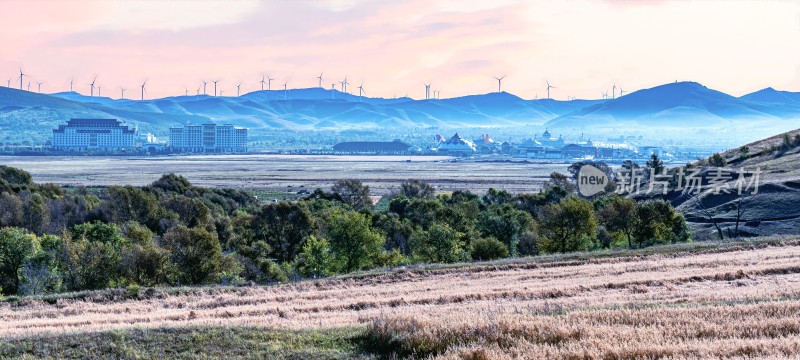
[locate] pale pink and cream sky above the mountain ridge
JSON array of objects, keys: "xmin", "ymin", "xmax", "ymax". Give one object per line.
[{"xmin": 0, "ymin": 0, "xmax": 800, "ymax": 100}]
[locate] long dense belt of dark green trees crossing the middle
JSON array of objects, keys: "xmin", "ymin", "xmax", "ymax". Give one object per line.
[{"xmin": 0, "ymin": 166, "xmax": 689, "ymax": 295}]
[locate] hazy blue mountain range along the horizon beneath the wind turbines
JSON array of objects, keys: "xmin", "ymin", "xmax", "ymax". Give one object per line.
[{"xmin": 0, "ymin": 82, "xmax": 800, "ymax": 138}]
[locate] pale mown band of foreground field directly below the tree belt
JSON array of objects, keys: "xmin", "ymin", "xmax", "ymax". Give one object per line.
[{"xmin": 0, "ymin": 242, "xmax": 800, "ymax": 340}]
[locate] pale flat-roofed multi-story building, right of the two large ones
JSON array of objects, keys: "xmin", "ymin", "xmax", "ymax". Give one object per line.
[{"xmin": 169, "ymin": 123, "xmax": 247, "ymax": 153}]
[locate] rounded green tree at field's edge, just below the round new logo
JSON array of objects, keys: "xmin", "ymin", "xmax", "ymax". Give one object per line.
[{"xmin": 542, "ymin": 196, "xmax": 597, "ymax": 253}]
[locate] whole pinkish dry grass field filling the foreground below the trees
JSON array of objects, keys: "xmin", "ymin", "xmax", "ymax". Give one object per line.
[{"xmin": 0, "ymin": 239, "xmax": 800, "ymax": 359}]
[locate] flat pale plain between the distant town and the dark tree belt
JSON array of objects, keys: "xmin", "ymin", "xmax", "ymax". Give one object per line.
[{"xmin": 0, "ymin": 155, "xmax": 569, "ymax": 195}]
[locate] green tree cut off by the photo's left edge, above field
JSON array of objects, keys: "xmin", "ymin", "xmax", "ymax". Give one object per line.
[{"xmin": 0, "ymin": 228, "xmax": 39, "ymax": 294}]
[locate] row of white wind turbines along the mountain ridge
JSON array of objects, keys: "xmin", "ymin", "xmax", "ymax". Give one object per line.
[{"xmin": 6, "ymin": 68, "xmax": 626, "ymax": 100}]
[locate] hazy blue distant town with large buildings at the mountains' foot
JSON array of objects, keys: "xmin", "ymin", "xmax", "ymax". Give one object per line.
[{"xmin": 0, "ymin": 118, "xmax": 719, "ymax": 161}]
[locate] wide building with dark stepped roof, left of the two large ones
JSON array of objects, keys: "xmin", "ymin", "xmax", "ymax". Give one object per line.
[{"xmin": 52, "ymin": 119, "xmax": 136, "ymax": 152}]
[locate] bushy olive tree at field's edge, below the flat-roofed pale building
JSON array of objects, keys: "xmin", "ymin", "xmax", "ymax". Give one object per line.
[{"xmin": 162, "ymin": 225, "xmax": 222, "ymax": 285}]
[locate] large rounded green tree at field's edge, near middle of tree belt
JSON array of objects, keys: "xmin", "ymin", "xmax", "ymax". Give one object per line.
[{"xmin": 326, "ymin": 209, "xmax": 383, "ymax": 272}]
